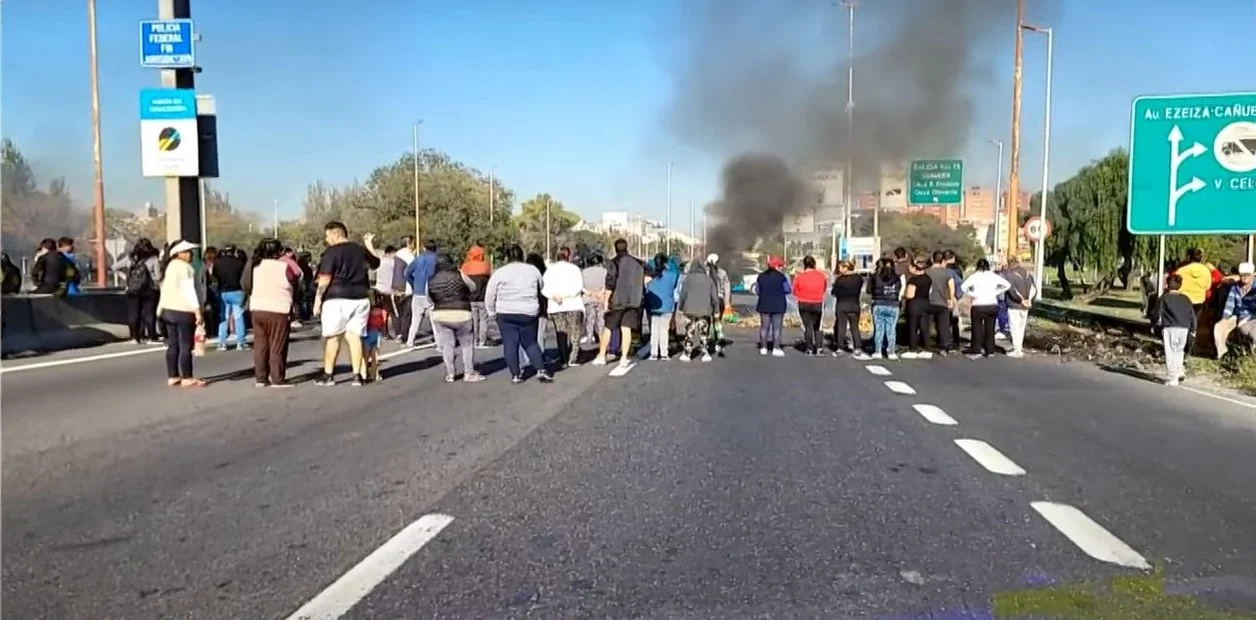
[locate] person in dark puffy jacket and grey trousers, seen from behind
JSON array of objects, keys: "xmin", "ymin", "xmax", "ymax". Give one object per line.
[{"xmin": 427, "ymin": 254, "xmax": 484, "ymax": 383}]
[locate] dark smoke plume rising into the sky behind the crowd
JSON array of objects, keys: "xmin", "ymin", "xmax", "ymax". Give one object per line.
[{"xmin": 666, "ymin": 0, "xmax": 1016, "ymax": 257}]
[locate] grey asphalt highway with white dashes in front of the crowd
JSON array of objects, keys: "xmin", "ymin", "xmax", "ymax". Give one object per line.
[{"xmin": 0, "ymin": 331, "xmax": 1256, "ymax": 620}]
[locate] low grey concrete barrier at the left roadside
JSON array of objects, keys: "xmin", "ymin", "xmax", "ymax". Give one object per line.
[{"xmin": 0, "ymin": 291, "xmax": 129, "ymax": 356}]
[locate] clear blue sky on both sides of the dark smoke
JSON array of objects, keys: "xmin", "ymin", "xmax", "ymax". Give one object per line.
[{"xmin": 0, "ymin": 0, "xmax": 1256, "ymax": 227}]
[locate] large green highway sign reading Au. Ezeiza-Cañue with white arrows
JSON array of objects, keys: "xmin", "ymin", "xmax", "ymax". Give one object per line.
[{"xmin": 1125, "ymin": 93, "xmax": 1256, "ymax": 235}]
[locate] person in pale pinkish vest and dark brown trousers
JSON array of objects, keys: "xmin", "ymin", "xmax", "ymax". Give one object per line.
[{"xmin": 242, "ymin": 238, "xmax": 300, "ymax": 388}]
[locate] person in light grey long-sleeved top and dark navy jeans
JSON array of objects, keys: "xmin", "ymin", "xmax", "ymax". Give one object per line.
[{"xmin": 484, "ymin": 243, "xmax": 554, "ymax": 384}]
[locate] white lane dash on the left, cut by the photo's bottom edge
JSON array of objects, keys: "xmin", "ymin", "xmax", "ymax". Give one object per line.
[{"xmin": 288, "ymin": 515, "xmax": 453, "ymax": 620}]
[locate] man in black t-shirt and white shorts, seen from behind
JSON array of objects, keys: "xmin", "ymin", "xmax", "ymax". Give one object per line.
[{"xmin": 314, "ymin": 222, "xmax": 379, "ymax": 385}]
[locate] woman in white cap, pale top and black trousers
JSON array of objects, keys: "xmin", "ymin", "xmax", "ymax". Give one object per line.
[{"xmin": 157, "ymin": 240, "xmax": 206, "ymax": 388}]
